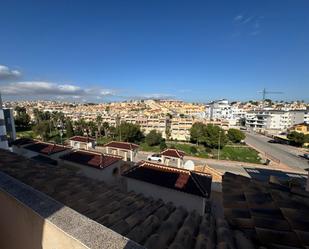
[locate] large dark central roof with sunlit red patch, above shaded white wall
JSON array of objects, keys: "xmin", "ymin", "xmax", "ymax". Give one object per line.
[{"xmin": 123, "ymin": 161, "xmax": 211, "ymax": 197}]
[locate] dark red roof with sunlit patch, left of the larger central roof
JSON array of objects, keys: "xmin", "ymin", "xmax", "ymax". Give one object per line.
[{"xmin": 60, "ymin": 150, "xmax": 122, "ymax": 169}]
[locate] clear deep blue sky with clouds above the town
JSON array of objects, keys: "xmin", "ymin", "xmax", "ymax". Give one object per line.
[{"xmin": 0, "ymin": 0, "xmax": 309, "ymax": 102}]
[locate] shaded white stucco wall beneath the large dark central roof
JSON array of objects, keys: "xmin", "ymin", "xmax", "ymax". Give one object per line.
[{"xmin": 125, "ymin": 177, "xmax": 206, "ymax": 215}]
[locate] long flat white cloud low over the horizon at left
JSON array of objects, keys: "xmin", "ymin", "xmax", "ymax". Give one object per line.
[{"xmin": 1, "ymin": 81, "xmax": 113, "ymax": 98}]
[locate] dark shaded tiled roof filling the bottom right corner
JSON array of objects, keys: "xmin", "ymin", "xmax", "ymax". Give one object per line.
[{"xmin": 223, "ymin": 173, "xmax": 309, "ymax": 249}]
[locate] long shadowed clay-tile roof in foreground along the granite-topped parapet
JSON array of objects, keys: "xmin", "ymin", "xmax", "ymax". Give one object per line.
[{"xmin": 0, "ymin": 150, "xmax": 253, "ymax": 249}]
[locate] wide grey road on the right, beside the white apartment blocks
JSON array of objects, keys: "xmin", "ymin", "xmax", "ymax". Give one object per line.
[{"xmin": 245, "ymin": 132, "xmax": 309, "ymax": 169}]
